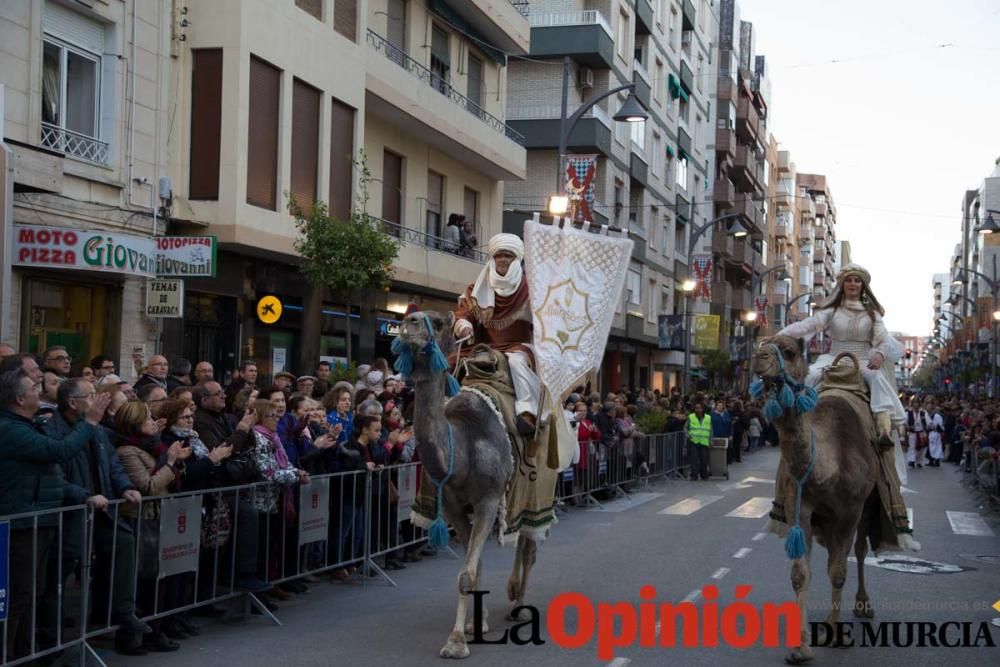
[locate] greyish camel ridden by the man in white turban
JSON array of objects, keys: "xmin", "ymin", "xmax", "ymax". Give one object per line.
[{"xmin": 399, "ymin": 311, "xmax": 537, "ymax": 658}]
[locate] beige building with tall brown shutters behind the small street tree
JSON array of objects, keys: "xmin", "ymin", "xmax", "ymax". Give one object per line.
[{"xmin": 156, "ymin": 0, "xmax": 530, "ymax": 375}]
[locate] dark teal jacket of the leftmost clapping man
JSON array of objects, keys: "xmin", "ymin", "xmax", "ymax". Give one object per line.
[{"xmin": 0, "ymin": 409, "xmax": 94, "ymax": 529}]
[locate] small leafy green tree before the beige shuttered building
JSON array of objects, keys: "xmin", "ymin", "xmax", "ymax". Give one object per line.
[{"xmin": 288, "ymin": 151, "xmax": 400, "ymax": 368}]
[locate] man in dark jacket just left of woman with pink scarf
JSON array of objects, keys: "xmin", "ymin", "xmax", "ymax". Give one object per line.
[{"xmin": 191, "ymin": 381, "xmax": 270, "ymax": 593}]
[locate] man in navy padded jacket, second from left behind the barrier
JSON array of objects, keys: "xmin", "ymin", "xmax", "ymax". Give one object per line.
[{"xmin": 42, "ymin": 378, "xmax": 149, "ymax": 653}]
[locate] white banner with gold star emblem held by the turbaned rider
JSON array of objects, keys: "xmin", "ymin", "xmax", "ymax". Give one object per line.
[{"xmin": 524, "ymin": 220, "xmax": 632, "ymax": 400}]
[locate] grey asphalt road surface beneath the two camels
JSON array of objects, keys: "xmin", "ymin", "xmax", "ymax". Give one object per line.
[{"xmin": 101, "ymin": 449, "xmax": 1000, "ymax": 667}]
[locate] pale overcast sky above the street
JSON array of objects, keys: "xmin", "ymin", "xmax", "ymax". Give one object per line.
[{"xmin": 736, "ymin": 0, "xmax": 1000, "ymax": 335}]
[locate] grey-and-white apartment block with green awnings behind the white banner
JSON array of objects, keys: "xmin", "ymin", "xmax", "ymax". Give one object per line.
[{"xmin": 504, "ymin": 0, "xmax": 718, "ymax": 391}]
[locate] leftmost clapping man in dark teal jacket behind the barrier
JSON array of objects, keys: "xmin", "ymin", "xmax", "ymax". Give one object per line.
[{"xmin": 0, "ymin": 370, "xmax": 110, "ymax": 658}]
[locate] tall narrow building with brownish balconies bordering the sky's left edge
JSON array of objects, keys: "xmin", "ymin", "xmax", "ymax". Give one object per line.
[{"xmin": 711, "ymin": 0, "xmax": 770, "ymax": 362}]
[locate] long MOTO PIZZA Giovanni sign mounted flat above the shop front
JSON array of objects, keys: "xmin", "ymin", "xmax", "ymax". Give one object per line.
[{"xmin": 12, "ymin": 225, "xmax": 156, "ymax": 277}]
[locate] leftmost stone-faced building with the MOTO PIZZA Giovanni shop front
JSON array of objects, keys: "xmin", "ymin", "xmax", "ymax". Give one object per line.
[{"xmin": 0, "ymin": 0, "xmax": 172, "ymax": 368}]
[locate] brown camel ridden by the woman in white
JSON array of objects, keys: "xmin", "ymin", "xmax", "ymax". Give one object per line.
[{"xmin": 752, "ymin": 336, "xmax": 879, "ymax": 664}]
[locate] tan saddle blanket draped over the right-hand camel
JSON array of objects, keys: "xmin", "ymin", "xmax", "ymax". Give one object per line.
[{"xmin": 770, "ymin": 365, "xmax": 913, "ymax": 551}]
